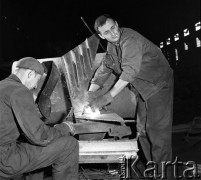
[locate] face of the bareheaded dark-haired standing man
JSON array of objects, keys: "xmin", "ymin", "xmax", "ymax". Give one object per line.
[{"xmin": 98, "ymin": 19, "xmax": 120, "ymax": 42}]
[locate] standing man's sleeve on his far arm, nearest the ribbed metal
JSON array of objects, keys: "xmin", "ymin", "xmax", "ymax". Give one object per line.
[{"xmin": 91, "ymin": 60, "xmax": 112, "ymax": 87}]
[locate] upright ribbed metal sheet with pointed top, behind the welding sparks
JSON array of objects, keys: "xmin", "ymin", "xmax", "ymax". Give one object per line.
[{"xmin": 60, "ymin": 35, "xmax": 99, "ymax": 112}]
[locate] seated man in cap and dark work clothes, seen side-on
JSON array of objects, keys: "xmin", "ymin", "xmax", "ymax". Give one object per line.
[{"xmin": 0, "ymin": 57, "xmax": 79, "ymax": 180}]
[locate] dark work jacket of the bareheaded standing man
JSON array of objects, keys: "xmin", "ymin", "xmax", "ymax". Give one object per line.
[{"xmin": 91, "ymin": 28, "xmax": 172, "ymax": 100}]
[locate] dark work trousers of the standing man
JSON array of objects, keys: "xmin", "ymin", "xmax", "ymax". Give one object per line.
[{"xmin": 137, "ymin": 77, "xmax": 173, "ymax": 177}]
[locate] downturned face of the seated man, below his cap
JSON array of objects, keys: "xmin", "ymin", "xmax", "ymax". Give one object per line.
[{"xmin": 25, "ymin": 71, "xmax": 41, "ymax": 90}]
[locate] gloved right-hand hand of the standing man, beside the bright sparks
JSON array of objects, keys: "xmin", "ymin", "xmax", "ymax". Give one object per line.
[{"xmin": 89, "ymin": 92, "xmax": 113, "ymax": 111}]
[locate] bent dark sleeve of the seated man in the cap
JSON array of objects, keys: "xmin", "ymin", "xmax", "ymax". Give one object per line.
[{"xmin": 11, "ymin": 88, "xmax": 69, "ymax": 146}]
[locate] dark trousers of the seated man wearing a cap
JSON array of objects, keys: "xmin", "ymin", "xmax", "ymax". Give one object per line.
[{"xmin": 0, "ymin": 136, "xmax": 79, "ymax": 180}]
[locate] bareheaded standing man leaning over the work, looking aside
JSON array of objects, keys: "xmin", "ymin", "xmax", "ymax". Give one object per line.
[{"xmin": 89, "ymin": 14, "xmax": 173, "ymax": 179}]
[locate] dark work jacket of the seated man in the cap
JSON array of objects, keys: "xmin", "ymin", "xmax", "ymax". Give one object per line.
[{"xmin": 0, "ymin": 74, "xmax": 69, "ymax": 148}]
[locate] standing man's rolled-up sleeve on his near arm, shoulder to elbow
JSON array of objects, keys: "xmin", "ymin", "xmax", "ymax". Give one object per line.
[{"xmin": 120, "ymin": 38, "xmax": 142, "ymax": 83}]
